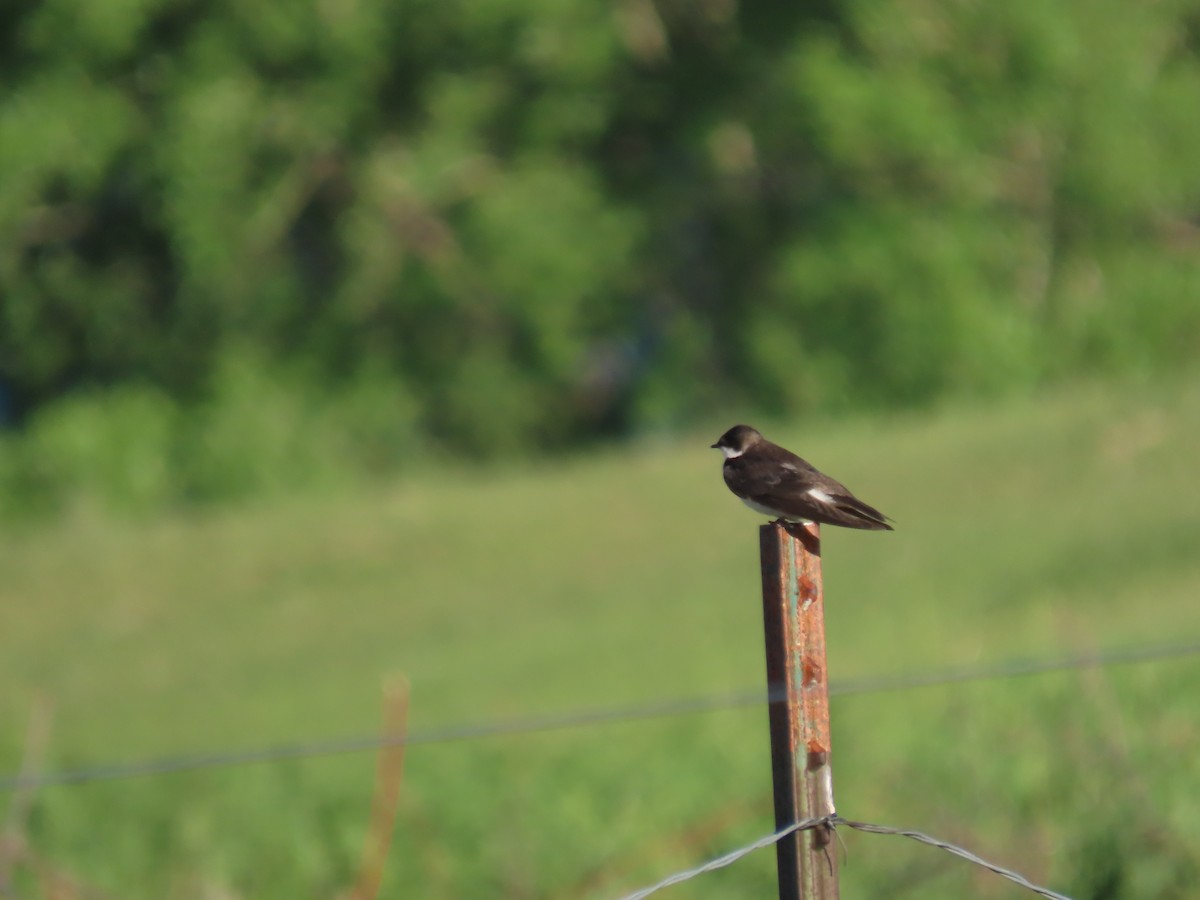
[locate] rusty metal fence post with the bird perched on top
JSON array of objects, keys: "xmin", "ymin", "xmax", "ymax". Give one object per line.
[{"xmin": 758, "ymin": 523, "xmax": 838, "ymax": 900}]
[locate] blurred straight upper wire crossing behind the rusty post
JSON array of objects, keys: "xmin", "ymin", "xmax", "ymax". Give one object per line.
[{"xmin": 0, "ymin": 640, "xmax": 1200, "ymax": 791}]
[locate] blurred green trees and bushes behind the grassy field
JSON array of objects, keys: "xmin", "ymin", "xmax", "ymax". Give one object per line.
[{"xmin": 0, "ymin": 0, "xmax": 1200, "ymax": 506}]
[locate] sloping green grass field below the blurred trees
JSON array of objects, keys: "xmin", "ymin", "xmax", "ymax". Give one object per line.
[{"xmin": 0, "ymin": 378, "xmax": 1200, "ymax": 900}]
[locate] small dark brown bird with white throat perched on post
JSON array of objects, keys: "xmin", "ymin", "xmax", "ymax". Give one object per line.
[{"xmin": 713, "ymin": 425, "xmax": 893, "ymax": 532}]
